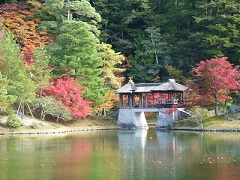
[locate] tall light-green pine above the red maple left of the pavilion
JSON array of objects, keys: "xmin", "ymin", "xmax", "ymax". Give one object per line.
[{"xmin": 43, "ymin": 0, "xmax": 105, "ymax": 105}]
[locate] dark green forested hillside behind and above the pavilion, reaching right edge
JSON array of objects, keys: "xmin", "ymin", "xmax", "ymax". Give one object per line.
[{"xmin": 94, "ymin": 0, "xmax": 240, "ymax": 82}]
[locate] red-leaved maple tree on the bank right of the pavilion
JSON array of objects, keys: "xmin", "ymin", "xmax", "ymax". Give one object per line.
[{"xmin": 192, "ymin": 57, "xmax": 240, "ymax": 115}]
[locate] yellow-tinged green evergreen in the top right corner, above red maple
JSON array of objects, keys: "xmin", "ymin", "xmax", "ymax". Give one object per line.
[{"xmin": 195, "ymin": 0, "xmax": 240, "ymax": 64}]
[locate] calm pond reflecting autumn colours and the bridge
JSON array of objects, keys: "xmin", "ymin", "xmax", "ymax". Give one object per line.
[{"xmin": 0, "ymin": 129, "xmax": 240, "ymax": 180}]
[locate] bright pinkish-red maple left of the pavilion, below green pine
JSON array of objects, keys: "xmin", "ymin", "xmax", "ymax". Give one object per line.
[{"xmin": 45, "ymin": 76, "xmax": 92, "ymax": 119}]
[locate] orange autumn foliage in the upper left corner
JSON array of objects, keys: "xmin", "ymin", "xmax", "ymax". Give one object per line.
[{"xmin": 0, "ymin": 3, "xmax": 49, "ymax": 63}]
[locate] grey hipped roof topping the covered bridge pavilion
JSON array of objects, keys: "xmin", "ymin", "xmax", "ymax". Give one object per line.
[{"xmin": 116, "ymin": 79, "xmax": 187, "ymax": 94}]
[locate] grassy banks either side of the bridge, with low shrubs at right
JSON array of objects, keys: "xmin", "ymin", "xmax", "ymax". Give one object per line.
[{"xmin": 0, "ymin": 113, "xmax": 240, "ymax": 135}]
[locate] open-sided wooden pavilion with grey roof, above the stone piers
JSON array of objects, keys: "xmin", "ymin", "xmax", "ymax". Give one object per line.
[{"xmin": 116, "ymin": 79, "xmax": 187, "ymax": 109}]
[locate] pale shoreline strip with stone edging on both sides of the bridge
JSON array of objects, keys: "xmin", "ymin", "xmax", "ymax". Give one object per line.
[{"xmin": 0, "ymin": 116, "xmax": 240, "ymax": 136}]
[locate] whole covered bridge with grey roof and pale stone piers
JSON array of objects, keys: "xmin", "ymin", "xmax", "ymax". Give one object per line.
[{"xmin": 116, "ymin": 79, "xmax": 188, "ymax": 129}]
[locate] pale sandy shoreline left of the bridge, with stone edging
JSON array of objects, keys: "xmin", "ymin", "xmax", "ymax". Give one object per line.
[{"xmin": 0, "ymin": 116, "xmax": 119, "ymax": 136}]
